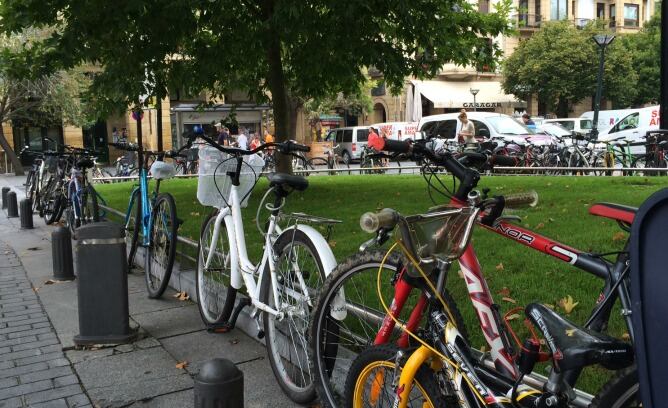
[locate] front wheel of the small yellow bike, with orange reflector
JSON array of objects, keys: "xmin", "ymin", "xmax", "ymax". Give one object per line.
[{"xmin": 345, "ymin": 346, "xmax": 449, "ymax": 408}]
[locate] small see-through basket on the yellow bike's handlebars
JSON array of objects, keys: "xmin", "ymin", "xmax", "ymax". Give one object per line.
[{"xmin": 406, "ymin": 207, "xmax": 478, "ymax": 263}]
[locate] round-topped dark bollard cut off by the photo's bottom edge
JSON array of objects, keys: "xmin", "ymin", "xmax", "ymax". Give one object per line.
[{"xmin": 195, "ymin": 358, "xmax": 244, "ymax": 408}]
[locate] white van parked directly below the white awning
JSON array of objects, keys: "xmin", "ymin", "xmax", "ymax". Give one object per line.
[{"xmin": 416, "ymin": 112, "xmax": 534, "ymax": 143}]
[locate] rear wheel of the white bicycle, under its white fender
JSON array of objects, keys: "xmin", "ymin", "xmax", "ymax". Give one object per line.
[{"xmin": 260, "ymin": 229, "xmax": 325, "ymax": 404}]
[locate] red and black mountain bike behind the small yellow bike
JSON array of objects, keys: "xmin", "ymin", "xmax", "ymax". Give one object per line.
[{"xmin": 309, "ymin": 141, "xmax": 635, "ymax": 407}]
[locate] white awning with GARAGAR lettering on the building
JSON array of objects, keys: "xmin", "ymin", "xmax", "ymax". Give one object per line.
[{"xmin": 412, "ymin": 81, "xmax": 520, "ymax": 109}]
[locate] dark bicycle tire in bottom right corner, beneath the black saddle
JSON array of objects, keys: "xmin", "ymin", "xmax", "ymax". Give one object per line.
[{"xmin": 589, "ymin": 366, "xmax": 642, "ymax": 408}]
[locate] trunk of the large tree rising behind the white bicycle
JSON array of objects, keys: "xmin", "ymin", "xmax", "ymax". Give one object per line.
[{"xmin": 262, "ymin": 0, "xmax": 292, "ymax": 173}]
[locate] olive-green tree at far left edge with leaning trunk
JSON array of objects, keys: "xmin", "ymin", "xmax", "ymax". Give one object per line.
[{"xmin": 0, "ymin": 29, "xmax": 93, "ymax": 175}]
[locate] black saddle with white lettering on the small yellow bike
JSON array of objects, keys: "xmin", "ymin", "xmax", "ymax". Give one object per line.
[{"xmin": 525, "ymin": 303, "xmax": 634, "ymax": 372}]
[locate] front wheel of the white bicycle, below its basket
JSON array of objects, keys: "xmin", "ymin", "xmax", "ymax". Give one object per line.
[{"xmin": 196, "ymin": 210, "xmax": 237, "ymax": 325}]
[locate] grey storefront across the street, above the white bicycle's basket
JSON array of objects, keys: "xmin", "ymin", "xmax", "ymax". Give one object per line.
[{"xmin": 170, "ymin": 103, "xmax": 271, "ymax": 147}]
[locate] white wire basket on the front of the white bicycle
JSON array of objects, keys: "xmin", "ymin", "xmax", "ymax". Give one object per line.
[{"xmin": 197, "ymin": 146, "xmax": 264, "ymax": 208}]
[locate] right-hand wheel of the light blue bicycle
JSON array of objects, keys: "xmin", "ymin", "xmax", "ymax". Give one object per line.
[{"xmin": 144, "ymin": 193, "xmax": 179, "ymax": 299}]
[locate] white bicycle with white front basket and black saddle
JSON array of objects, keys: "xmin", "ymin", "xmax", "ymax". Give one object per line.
[{"xmin": 197, "ymin": 136, "xmax": 339, "ymax": 404}]
